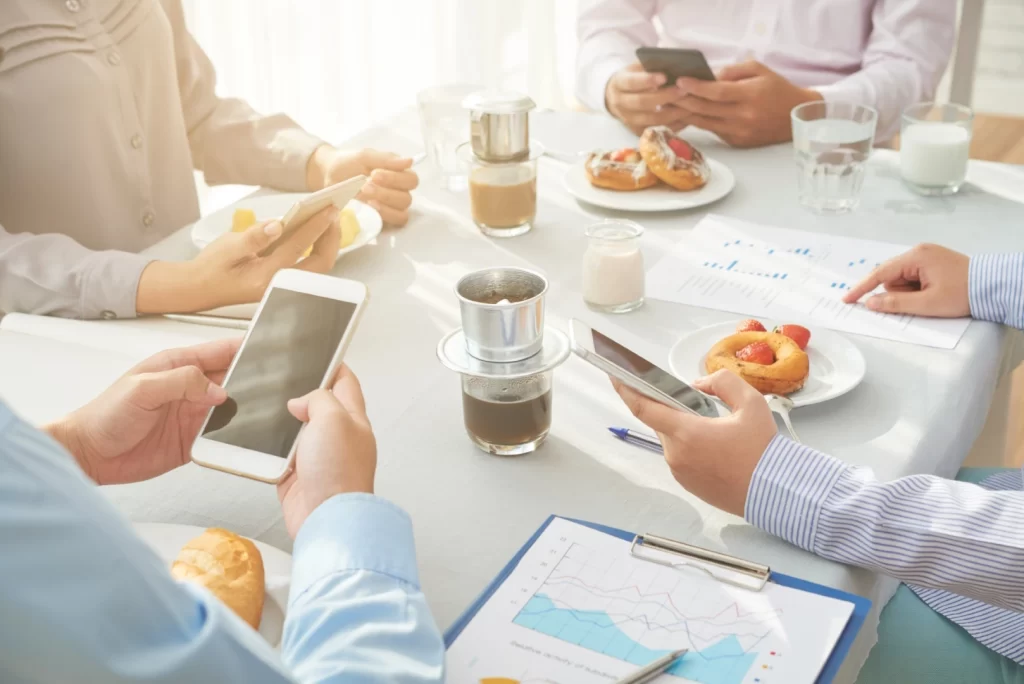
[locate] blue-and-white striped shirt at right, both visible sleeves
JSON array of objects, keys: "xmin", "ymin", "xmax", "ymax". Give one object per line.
[{"xmin": 745, "ymin": 254, "xmax": 1024, "ymax": 665}]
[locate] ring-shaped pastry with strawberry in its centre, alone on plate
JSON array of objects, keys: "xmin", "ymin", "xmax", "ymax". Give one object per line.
[{"xmin": 705, "ymin": 330, "xmax": 810, "ymax": 394}]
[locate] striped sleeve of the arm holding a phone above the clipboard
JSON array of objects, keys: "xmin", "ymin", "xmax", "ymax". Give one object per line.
[{"xmin": 745, "ymin": 436, "xmax": 1024, "ymax": 610}]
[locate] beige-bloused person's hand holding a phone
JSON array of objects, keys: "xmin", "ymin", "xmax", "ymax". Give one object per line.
[{"xmin": 135, "ymin": 207, "xmax": 341, "ymax": 313}]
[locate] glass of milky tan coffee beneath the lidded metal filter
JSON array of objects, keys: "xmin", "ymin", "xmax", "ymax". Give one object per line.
[{"xmin": 460, "ymin": 143, "xmax": 543, "ymax": 238}]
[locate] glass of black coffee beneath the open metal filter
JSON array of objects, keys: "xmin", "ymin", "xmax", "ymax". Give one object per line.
[{"xmin": 462, "ymin": 371, "xmax": 554, "ymax": 456}]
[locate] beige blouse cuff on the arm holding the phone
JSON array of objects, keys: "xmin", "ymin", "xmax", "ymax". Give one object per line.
[{"xmin": 79, "ymin": 250, "xmax": 153, "ymax": 318}]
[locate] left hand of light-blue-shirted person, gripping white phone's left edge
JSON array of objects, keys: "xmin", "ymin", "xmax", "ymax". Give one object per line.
[{"xmin": 44, "ymin": 338, "xmax": 242, "ymax": 484}]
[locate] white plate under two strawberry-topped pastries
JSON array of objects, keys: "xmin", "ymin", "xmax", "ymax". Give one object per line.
[{"xmin": 563, "ymin": 157, "xmax": 736, "ymax": 211}]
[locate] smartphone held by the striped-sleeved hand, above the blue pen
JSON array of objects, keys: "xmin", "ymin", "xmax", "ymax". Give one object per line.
[{"xmin": 569, "ymin": 318, "xmax": 718, "ymax": 418}]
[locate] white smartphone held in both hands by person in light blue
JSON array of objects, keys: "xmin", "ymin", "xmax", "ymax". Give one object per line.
[{"xmin": 193, "ymin": 269, "xmax": 369, "ymax": 483}]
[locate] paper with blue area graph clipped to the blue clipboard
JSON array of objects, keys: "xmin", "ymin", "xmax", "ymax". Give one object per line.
[{"xmin": 446, "ymin": 518, "xmax": 854, "ymax": 684}]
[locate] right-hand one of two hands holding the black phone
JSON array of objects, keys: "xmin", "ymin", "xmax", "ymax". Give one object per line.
[{"xmin": 676, "ymin": 61, "xmax": 822, "ymax": 147}]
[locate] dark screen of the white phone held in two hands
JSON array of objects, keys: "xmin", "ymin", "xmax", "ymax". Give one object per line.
[{"xmin": 203, "ymin": 288, "xmax": 356, "ymax": 459}]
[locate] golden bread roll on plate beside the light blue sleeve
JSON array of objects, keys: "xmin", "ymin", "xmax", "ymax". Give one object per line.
[{"xmin": 171, "ymin": 527, "xmax": 266, "ymax": 630}]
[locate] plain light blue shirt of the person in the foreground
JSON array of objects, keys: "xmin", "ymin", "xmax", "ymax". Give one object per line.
[{"xmin": 0, "ymin": 403, "xmax": 444, "ymax": 684}]
